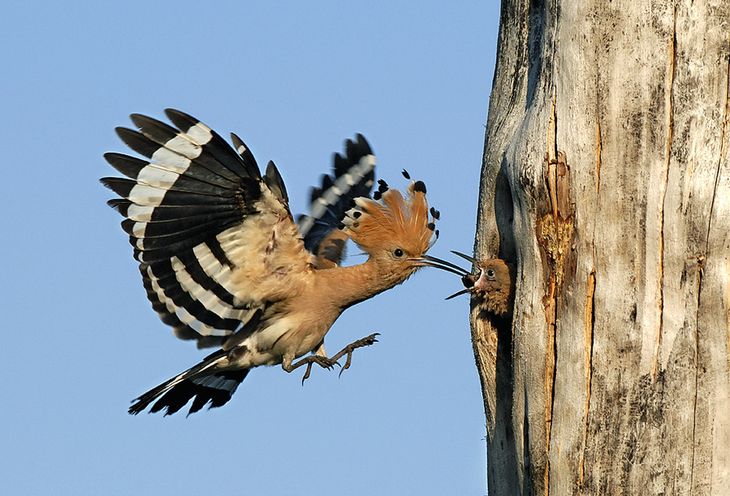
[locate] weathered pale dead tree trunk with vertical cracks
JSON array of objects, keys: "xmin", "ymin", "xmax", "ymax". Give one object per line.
[{"xmin": 472, "ymin": 0, "xmax": 730, "ymax": 496}]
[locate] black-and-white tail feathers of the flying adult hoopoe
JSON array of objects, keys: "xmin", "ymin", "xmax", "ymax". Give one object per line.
[{"xmin": 129, "ymin": 352, "xmax": 249, "ymax": 415}]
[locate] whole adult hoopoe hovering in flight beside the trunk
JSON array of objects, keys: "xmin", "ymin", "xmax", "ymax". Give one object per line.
[{"xmin": 102, "ymin": 109, "xmax": 460, "ymax": 414}]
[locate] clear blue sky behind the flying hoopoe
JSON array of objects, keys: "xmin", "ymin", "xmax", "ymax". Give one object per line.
[{"xmin": 0, "ymin": 1, "xmax": 499, "ymax": 496}]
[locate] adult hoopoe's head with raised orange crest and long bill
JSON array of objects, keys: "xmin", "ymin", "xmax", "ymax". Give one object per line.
[{"xmin": 336, "ymin": 171, "xmax": 456, "ymax": 284}]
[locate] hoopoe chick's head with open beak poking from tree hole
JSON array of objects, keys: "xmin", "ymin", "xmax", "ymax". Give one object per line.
[{"xmin": 446, "ymin": 251, "xmax": 514, "ymax": 316}]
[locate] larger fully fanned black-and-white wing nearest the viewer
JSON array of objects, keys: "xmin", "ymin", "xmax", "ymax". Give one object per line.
[{"xmin": 102, "ymin": 109, "xmax": 312, "ymax": 347}]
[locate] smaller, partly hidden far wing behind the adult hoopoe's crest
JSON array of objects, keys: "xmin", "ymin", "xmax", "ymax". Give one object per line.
[{"xmin": 298, "ymin": 134, "xmax": 375, "ymax": 268}]
